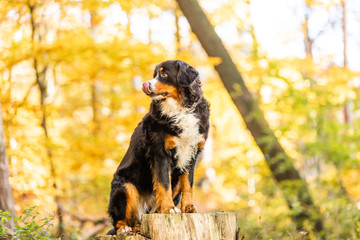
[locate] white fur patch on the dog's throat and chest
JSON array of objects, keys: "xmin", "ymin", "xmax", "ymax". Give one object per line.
[{"xmin": 161, "ymin": 98, "xmax": 203, "ymax": 169}]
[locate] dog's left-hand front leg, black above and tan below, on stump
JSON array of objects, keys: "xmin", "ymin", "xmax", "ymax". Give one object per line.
[{"xmin": 152, "ymin": 161, "xmax": 180, "ymax": 213}]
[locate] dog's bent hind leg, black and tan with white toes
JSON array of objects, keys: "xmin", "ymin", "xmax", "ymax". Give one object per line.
[{"xmin": 108, "ymin": 183, "xmax": 140, "ymax": 234}]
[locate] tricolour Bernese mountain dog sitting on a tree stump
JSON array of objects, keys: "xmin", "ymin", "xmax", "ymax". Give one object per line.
[{"xmin": 108, "ymin": 60, "xmax": 209, "ymax": 235}]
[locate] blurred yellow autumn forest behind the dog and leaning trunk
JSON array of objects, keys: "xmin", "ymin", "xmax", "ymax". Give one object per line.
[{"xmin": 0, "ymin": 0, "xmax": 360, "ymax": 239}]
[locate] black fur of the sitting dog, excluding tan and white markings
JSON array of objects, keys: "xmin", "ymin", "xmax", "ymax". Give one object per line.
[{"xmin": 108, "ymin": 60, "xmax": 209, "ymax": 234}]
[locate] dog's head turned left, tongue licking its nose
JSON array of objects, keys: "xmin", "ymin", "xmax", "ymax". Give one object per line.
[{"xmin": 143, "ymin": 60, "xmax": 202, "ymax": 107}]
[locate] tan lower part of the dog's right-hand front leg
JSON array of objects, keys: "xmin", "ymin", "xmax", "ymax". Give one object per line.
[{"xmin": 179, "ymin": 173, "xmax": 196, "ymax": 213}]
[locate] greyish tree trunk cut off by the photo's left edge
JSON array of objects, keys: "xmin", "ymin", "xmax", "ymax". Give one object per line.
[{"xmin": 0, "ymin": 100, "xmax": 15, "ymax": 228}]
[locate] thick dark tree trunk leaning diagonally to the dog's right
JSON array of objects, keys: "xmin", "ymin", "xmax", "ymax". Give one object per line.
[{"xmin": 177, "ymin": 0, "xmax": 323, "ymax": 233}]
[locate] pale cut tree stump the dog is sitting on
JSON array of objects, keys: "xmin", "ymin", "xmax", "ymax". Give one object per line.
[{"xmin": 96, "ymin": 212, "xmax": 237, "ymax": 240}]
